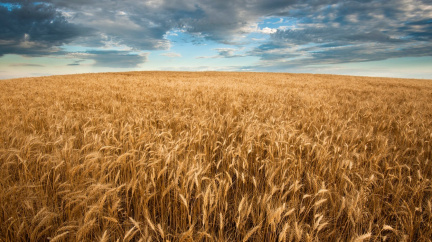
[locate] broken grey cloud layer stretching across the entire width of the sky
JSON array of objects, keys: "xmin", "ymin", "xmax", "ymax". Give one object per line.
[{"xmin": 0, "ymin": 0, "xmax": 432, "ymax": 69}]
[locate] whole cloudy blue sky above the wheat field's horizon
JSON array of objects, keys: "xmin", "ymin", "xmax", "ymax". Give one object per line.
[{"xmin": 0, "ymin": 0, "xmax": 432, "ymax": 79}]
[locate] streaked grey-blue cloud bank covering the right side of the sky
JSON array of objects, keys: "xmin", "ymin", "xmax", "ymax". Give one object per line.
[{"xmin": 248, "ymin": 0, "xmax": 432, "ymax": 70}]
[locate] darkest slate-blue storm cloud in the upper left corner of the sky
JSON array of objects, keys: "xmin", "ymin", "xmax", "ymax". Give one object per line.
[{"xmin": 0, "ymin": 2, "xmax": 88, "ymax": 56}]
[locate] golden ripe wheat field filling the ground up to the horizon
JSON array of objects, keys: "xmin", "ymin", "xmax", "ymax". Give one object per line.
[{"xmin": 0, "ymin": 72, "xmax": 432, "ymax": 241}]
